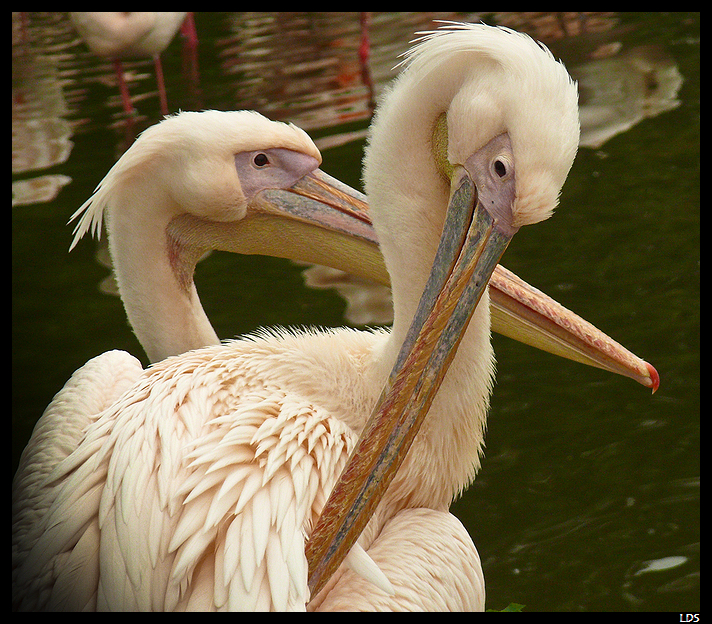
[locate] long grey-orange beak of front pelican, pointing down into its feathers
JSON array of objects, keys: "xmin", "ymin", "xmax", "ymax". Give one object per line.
[{"xmin": 306, "ymin": 167, "xmax": 514, "ymax": 596}]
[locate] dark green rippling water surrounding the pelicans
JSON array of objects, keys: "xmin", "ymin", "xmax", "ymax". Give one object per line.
[{"xmin": 12, "ymin": 13, "xmax": 700, "ymax": 611}]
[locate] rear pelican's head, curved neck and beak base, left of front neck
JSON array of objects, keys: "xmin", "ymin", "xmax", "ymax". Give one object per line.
[{"xmin": 70, "ymin": 111, "xmax": 381, "ymax": 362}]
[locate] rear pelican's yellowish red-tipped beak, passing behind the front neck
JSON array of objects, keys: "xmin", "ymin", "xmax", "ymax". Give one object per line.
[{"xmin": 171, "ymin": 169, "xmax": 659, "ymax": 392}]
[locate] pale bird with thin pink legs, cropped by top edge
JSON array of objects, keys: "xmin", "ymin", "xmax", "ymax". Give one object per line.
[{"xmin": 69, "ymin": 11, "xmax": 194, "ymax": 115}]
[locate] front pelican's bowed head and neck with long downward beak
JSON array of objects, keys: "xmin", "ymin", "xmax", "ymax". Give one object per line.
[{"xmin": 307, "ymin": 24, "xmax": 579, "ymax": 596}]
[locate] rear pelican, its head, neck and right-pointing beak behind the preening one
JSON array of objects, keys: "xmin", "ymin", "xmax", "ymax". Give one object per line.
[{"xmin": 64, "ymin": 103, "xmax": 650, "ymax": 385}]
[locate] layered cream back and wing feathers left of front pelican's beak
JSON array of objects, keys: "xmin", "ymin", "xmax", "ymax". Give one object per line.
[{"xmin": 14, "ymin": 330, "xmax": 385, "ymax": 610}]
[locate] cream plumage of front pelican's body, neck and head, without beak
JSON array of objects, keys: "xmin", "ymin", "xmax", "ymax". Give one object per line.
[{"xmin": 13, "ymin": 25, "xmax": 578, "ymax": 610}]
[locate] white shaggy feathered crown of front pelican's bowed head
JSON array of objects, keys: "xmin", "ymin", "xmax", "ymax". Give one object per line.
[{"xmin": 400, "ymin": 22, "xmax": 579, "ymax": 225}]
